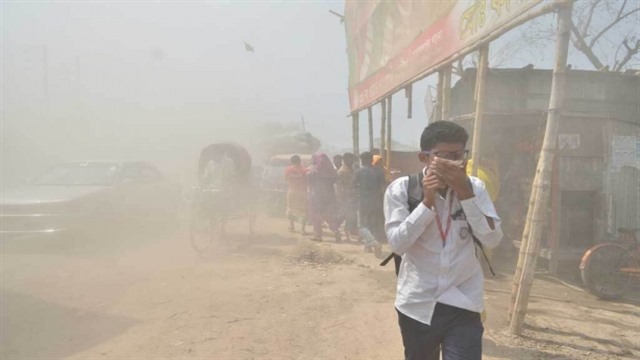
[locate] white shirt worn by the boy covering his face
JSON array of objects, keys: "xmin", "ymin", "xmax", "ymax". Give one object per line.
[{"xmin": 384, "ymin": 176, "xmax": 502, "ymax": 325}]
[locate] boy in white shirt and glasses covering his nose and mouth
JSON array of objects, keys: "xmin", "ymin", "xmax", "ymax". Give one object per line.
[{"xmin": 384, "ymin": 121, "xmax": 502, "ymax": 360}]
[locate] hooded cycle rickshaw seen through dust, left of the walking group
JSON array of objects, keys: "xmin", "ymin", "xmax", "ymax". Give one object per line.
[{"xmin": 190, "ymin": 143, "xmax": 257, "ymax": 253}]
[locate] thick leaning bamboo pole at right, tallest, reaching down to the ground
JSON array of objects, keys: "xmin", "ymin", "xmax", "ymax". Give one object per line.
[{"xmin": 509, "ymin": 0, "xmax": 573, "ymax": 335}]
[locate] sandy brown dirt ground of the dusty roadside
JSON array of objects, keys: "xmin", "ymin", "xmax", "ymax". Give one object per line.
[{"xmin": 0, "ymin": 217, "xmax": 640, "ymax": 359}]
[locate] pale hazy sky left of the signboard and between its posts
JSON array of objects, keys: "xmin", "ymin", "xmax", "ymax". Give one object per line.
[{"xmin": 0, "ymin": 1, "xmax": 616, "ymax": 184}]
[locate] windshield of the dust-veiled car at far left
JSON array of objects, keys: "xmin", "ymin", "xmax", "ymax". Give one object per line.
[{"xmin": 32, "ymin": 163, "xmax": 118, "ymax": 186}]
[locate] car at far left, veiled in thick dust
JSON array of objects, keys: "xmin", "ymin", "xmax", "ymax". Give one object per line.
[{"xmin": 0, "ymin": 162, "xmax": 179, "ymax": 238}]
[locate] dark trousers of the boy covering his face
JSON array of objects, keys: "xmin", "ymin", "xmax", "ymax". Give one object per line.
[{"xmin": 396, "ymin": 303, "xmax": 484, "ymax": 360}]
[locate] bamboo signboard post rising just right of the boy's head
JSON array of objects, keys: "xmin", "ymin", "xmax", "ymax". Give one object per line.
[{"xmin": 471, "ymin": 45, "xmax": 489, "ymax": 176}]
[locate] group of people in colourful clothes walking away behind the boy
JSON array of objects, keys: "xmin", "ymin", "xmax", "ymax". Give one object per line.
[{"xmin": 285, "ymin": 152, "xmax": 388, "ymax": 255}]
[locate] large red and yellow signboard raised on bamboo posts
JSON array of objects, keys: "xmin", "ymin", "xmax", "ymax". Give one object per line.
[{"xmin": 345, "ymin": 0, "xmax": 542, "ymax": 111}]
